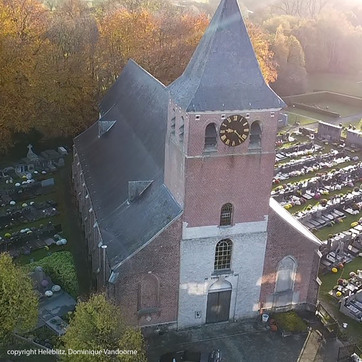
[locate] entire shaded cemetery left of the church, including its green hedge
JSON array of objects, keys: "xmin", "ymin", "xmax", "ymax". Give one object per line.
[{"xmin": 0, "ymin": 145, "xmax": 78, "ymax": 348}]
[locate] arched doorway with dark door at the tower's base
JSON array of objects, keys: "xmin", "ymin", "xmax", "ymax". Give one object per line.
[{"xmin": 206, "ymin": 279, "xmax": 232, "ymax": 323}]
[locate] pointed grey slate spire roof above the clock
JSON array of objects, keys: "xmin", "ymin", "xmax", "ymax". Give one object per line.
[{"xmin": 169, "ymin": 0, "xmax": 285, "ymax": 112}]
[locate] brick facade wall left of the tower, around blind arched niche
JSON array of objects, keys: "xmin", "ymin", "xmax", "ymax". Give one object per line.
[{"xmin": 108, "ymin": 219, "xmax": 182, "ymax": 326}]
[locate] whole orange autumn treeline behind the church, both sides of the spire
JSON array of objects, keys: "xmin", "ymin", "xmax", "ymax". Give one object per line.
[{"xmin": 0, "ymin": 0, "xmax": 276, "ymax": 152}]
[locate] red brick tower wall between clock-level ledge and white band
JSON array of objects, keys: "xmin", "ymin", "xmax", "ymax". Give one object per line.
[{"xmin": 184, "ymin": 154, "xmax": 274, "ymax": 227}]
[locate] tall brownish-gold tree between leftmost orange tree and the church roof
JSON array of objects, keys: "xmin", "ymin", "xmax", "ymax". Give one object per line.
[{"xmin": 34, "ymin": 0, "xmax": 98, "ymax": 137}]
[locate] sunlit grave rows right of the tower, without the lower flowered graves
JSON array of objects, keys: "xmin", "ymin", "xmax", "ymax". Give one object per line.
[{"xmin": 272, "ymin": 133, "xmax": 362, "ymax": 272}]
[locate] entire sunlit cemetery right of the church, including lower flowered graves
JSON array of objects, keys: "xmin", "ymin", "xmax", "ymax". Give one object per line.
[{"xmin": 272, "ymin": 122, "xmax": 362, "ymax": 330}]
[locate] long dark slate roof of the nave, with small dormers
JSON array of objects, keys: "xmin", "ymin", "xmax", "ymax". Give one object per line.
[{"xmin": 75, "ymin": 61, "xmax": 182, "ymax": 267}]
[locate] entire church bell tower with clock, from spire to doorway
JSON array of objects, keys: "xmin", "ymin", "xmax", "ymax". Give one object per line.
[{"xmin": 165, "ymin": 0, "xmax": 284, "ymax": 327}]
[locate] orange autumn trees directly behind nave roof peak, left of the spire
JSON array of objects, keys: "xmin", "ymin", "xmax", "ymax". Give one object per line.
[{"xmin": 97, "ymin": 8, "xmax": 208, "ymax": 88}]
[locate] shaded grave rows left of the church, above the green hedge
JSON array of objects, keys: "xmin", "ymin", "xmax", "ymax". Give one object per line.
[{"xmin": 0, "ymin": 146, "xmax": 67, "ymax": 257}]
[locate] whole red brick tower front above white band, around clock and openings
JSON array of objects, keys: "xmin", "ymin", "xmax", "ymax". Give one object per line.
[{"xmin": 184, "ymin": 112, "xmax": 278, "ymax": 227}]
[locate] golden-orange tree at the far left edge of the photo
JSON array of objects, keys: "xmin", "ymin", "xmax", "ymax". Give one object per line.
[{"xmin": 0, "ymin": 0, "xmax": 47, "ymax": 152}]
